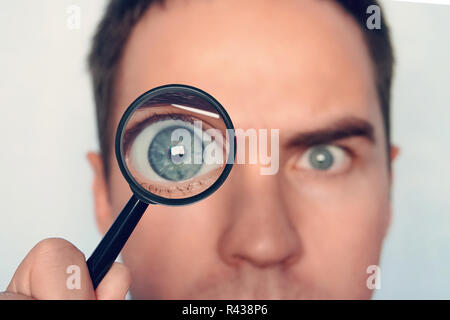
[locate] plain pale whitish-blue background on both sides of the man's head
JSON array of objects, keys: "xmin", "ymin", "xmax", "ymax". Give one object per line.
[{"xmin": 0, "ymin": 0, "xmax": 450, "ymax": 299}]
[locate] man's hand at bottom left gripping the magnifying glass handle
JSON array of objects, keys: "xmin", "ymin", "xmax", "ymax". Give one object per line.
[{"xmin": 0, "ymin": 238, "xmax": 131, "ymax": 300}]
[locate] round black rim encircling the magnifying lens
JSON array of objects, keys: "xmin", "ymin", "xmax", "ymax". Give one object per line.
[{"xmin": 115, "ymin": 84, "xmax": 236, "ymax": 206}]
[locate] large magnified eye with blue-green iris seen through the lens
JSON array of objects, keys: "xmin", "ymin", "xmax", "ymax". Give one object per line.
[{"xmin": 127, "ymin": 117, "xmax": 221, "ymax": 182}]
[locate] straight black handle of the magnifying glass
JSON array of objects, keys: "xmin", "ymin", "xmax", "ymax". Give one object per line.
[{"xmin": 86, "ymin": 195, "xmax": 148, "ymax": 290}]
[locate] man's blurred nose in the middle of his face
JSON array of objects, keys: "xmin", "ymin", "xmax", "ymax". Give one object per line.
[{"xmin": 219, "ymin": 165, "xmax": 301, "ymax": 268}]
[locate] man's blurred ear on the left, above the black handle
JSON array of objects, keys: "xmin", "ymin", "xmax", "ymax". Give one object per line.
[{"xmin": 87, "ymin": 152, "xmax": 113, "ymax": 234}]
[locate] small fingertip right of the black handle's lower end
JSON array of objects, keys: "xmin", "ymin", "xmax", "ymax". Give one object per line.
[{"xmin": 95, "ymin": 262, "xmax": 131, "ymax": 300}]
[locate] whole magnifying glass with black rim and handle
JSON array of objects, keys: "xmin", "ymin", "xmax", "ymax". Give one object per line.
[{"xmin": 87, "ymin": 84, "xmax": 236, "ymax": 289}]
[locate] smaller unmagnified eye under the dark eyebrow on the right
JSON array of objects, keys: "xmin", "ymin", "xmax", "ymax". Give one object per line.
[{"xmin": 295, "ymin": 145, "xmax": 351, "ymax": 173}]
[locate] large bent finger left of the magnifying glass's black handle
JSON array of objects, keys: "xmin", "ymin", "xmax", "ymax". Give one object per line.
[{"xmin": 7, "ymin": 238, "xmax": 95, "ymax": 300}]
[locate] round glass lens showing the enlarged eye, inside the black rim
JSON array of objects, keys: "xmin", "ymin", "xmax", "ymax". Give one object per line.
[{"xmin": 121, "ymin": 88, "xmax": 229, "ymax": 199}]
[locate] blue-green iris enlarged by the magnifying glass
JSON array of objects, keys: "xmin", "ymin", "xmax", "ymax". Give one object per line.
[{"xmin": 148, "ymin": 126, "xmax": 203, "ymax": 181}]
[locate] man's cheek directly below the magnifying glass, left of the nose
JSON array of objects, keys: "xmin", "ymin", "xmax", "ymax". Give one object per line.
[{"xmin": 118, "ymin": 192, "xmax": 223, "ymax": 299}]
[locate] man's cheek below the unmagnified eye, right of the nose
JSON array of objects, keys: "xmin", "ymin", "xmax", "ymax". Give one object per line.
[{"xmin": 285, "ymin": 168, "xmax": 390, "ymax": 297}]
